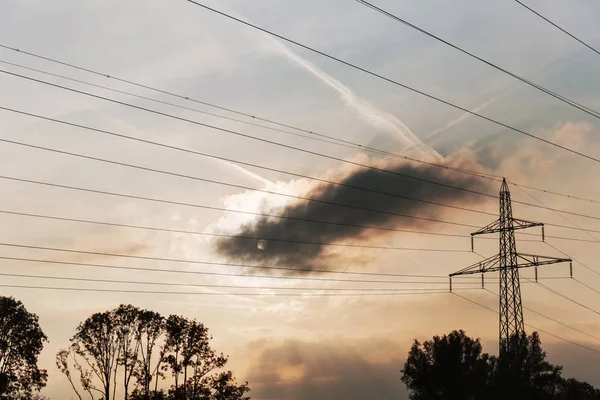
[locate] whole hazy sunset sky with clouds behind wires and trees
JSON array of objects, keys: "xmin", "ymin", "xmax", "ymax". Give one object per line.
[{"xmin": 0, "ymin": 0, "xmax": 600, "ymax": 400}]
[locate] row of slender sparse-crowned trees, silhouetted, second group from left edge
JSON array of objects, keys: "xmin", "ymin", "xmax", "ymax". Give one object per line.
[{"xmin": 56, "ymin": 305, "xmax": 249, "ymax": 400}]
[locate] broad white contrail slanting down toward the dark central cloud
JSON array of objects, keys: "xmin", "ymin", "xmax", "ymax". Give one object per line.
[{"xmin": 266, "ymin": 37, "xmax": 442, "ymax": 159}]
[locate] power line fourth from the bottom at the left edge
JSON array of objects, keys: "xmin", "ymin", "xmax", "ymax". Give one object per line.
[{"xmin": 0, "ymin": 242, "xmax": 472, "ymax": 279}]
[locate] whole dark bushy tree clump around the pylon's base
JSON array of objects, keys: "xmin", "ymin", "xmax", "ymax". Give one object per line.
[{"xmin": 402, "ymin": 331, "xmax": 600, "ymax": 400}]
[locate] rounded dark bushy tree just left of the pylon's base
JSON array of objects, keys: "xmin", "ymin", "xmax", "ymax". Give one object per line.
[{"xmin": 402, "ymin": 330, "xmax": 490, "ymax": 400}]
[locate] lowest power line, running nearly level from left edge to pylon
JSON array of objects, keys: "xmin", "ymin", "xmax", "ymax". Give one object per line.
[{"xmin": 0, "ymin": 284, "xmax": 449, "ymax": 297}]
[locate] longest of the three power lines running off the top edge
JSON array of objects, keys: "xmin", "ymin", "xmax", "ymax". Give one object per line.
[{"xmin": 186, "ymin": 0, "xmax": 600, "ymax": 163}]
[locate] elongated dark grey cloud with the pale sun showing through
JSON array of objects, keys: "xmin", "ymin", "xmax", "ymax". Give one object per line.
[{"xmin": 216, "ymin": 158, "xmax": 492, "ymax": 271}]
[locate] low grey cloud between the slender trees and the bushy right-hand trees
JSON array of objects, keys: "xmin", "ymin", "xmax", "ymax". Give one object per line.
[{"xmin": 247, "ymin": 341, "xmax": 408, "ymax": 400}]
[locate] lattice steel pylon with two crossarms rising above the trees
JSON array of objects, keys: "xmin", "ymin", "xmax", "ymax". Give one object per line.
[{"xmin": 450, "ymin": 179, "xmax": 573, "ymax": 353}]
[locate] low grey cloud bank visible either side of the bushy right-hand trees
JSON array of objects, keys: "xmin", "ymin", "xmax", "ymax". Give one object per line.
[{"xmin": 246, "ymin": 332, "xmax": 600, "ymax": 400}]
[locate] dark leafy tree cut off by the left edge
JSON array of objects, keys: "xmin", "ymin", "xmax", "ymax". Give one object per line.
[{"xmin": 0, "ymin": 297, "xmax": 48, "ymax": 399}]
